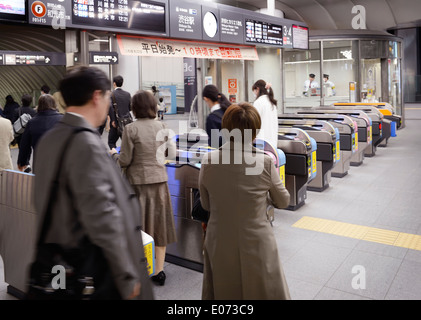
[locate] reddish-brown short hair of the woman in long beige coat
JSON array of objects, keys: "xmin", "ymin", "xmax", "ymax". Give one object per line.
[{"xmin": 222, "ymin": 102, "xmax": 262, "ymax": 141}]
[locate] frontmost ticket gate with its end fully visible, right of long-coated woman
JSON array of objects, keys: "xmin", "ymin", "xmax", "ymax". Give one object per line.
[{"xmin": 278, "ymin": 127, "xmax": 317, "ymax": 211}]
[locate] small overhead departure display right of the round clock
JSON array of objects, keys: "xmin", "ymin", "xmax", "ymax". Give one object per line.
[{"xmin": 246, "ymin": 19, "xmax": 283, "ymax": 46}]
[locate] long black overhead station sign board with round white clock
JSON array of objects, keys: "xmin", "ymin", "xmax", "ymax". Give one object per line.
[{"xmin": 28, "ymin": 0, "xmax": 308, "ymax": 48}]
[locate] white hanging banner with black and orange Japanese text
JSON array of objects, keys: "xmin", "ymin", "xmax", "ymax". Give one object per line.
[{"xmin": 117, "ymin": 35, "xmax": 259, "ymax": 60}]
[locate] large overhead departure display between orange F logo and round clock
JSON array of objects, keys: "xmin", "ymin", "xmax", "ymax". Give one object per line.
[{"xmin": 71, "ymin": 0, "xmax": 166, "ymax": 33}]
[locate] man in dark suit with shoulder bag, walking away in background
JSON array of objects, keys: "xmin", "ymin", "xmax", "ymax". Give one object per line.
[{"xmin": 108, "ymin": 76, "xmax": 132, "ymax": 149}]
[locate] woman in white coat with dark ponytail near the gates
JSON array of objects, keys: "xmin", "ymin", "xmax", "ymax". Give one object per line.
[{"xmin": 252, "ymin": 80, "xmax": 278, "ymax": 149}]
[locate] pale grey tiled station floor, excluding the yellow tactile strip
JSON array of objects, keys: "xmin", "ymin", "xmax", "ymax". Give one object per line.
[{"xmin": 0, "ymin": 105, "xmax": 421, "ymax": 300}]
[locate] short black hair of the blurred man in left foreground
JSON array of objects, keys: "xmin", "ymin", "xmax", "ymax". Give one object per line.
[{"xmin": 59, "ymin": 66, "xmax": 110, "ymax": 107}]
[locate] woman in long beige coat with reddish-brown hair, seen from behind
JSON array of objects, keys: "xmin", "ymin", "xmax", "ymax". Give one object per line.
[{"xmin": 199, "ymin": 103, "xmax": 290, "ymax": 300}]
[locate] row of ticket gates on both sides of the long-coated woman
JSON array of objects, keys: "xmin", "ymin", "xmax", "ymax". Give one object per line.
[{"xmin": 166, "ymin": 103, "xmax": 402, "ymax": 271}]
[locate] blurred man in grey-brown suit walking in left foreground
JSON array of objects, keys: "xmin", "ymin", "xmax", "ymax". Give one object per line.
[{"xmin": 34, "ymin": 66, "xmax": 153, "ymax": 299}]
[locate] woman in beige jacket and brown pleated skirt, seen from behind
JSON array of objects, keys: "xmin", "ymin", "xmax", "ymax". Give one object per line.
[{"xmin": 111, "ymin": 91, "xmax": 176, "ymax": 285}]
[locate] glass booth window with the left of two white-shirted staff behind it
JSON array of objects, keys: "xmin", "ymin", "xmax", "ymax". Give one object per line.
[{"xmin": 284, "ymin": 41, "xmax": 323, "ymax": 113}]
